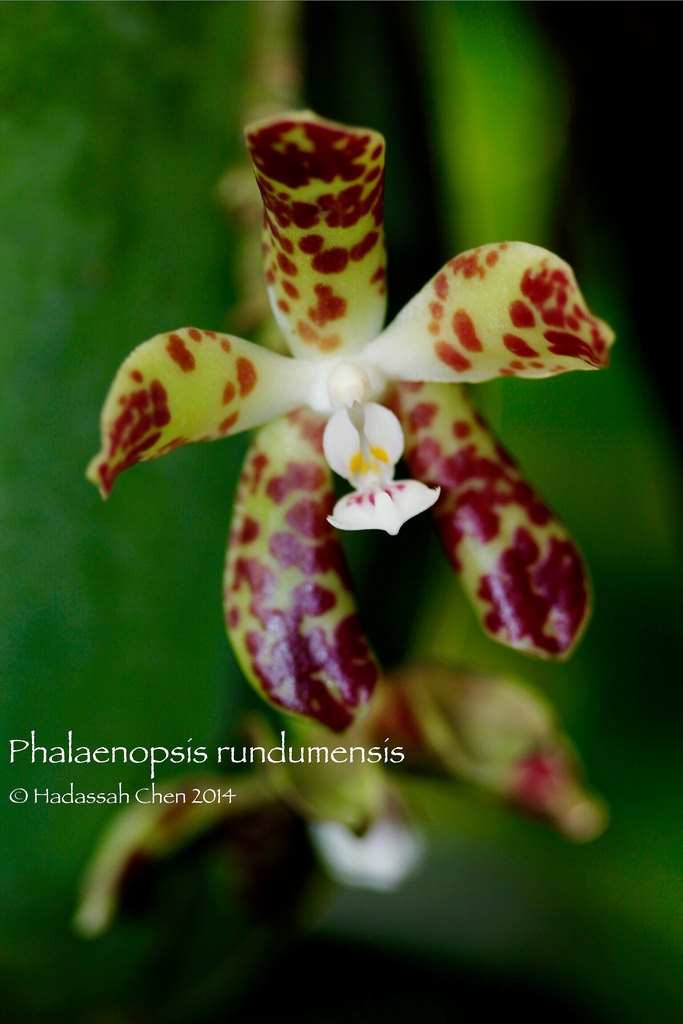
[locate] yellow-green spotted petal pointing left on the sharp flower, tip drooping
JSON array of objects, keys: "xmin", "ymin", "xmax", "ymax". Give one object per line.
[{"xmin": 87, "ymin": 327, "xmax": 312, "ymax": 498}]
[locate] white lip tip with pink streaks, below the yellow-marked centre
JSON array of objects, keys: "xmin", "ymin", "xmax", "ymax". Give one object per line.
[{"xmin": 328, "ymin": 480, "xmax": 439, "ymax": 536}]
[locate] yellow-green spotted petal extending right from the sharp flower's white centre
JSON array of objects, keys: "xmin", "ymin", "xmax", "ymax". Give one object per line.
[{"xmin": 364, "ymin": 242, "xmax": 614, "ymax": 382}]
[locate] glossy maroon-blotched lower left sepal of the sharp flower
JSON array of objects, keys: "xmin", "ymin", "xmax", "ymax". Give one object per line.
[{"xmin": 224, "ymin": 410, "xmax": 379, "ymax": 732}]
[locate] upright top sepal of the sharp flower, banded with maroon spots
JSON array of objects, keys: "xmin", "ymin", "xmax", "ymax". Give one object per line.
[{"xmin": 246, "ymin": 111, "xmax": 386, "ymax": 358}]
